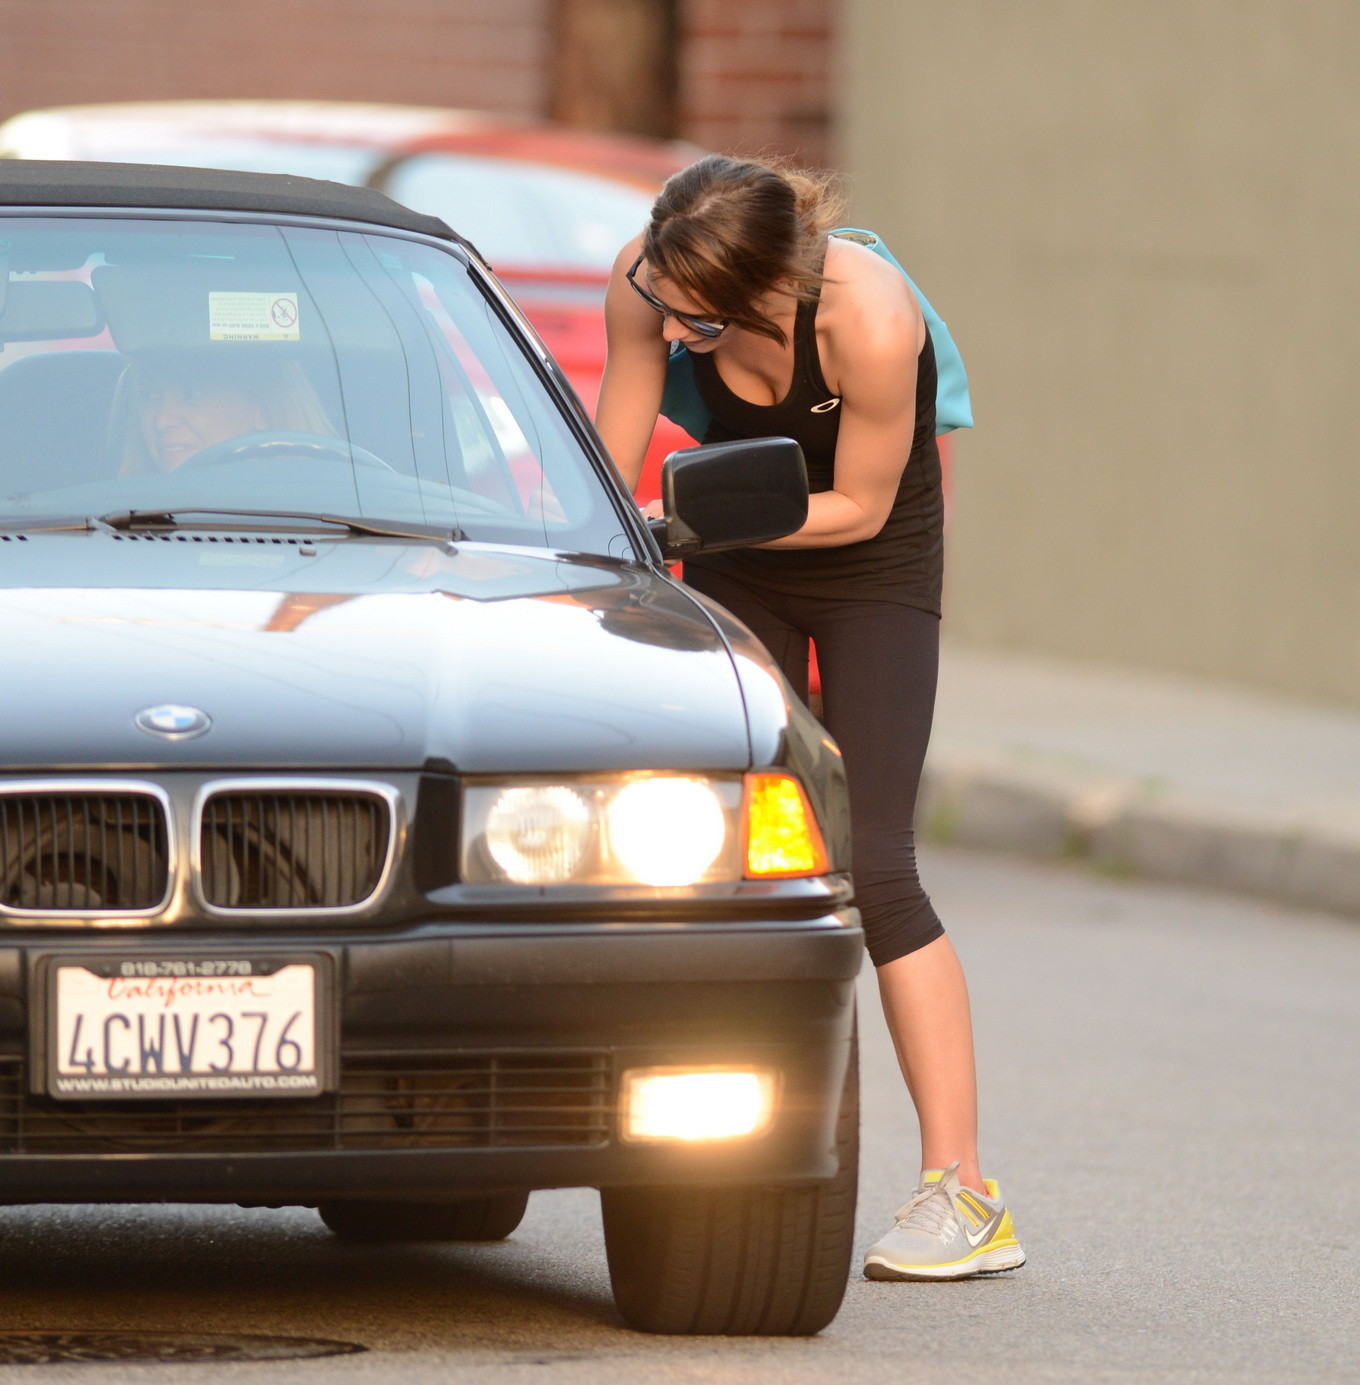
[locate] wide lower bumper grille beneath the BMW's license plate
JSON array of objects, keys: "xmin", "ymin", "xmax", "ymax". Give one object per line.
[{"xmin": 0, "ymin": 1051, "xmax": 614, "ymax": 1155}]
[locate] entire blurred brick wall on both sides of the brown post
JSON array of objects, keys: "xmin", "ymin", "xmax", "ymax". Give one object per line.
[{"xmin": 0, "ymin": 0, "xmax": 838, "ymax": 162}]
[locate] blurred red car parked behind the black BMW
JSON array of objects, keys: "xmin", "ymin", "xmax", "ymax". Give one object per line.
[{"xmin": 0, "ymin": 101, "xmax": 702, "ymax": 500}]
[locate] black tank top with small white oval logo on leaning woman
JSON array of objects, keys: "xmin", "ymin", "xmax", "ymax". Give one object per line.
[{"xmin": 686, "ymin": 283, "xmax": 945, "ymax": 615}]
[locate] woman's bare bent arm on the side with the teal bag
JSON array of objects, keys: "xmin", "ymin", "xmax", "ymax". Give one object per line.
[{"xmin": 762, "ymin": 245, "xmax": 925, "ymax": 548}]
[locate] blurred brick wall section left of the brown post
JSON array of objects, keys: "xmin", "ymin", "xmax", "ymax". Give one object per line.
[{"xmin": 0, "ymin": 0, "xmax": 550, "ymax": 116}]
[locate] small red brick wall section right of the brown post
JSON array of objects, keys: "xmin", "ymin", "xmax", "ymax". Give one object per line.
[{"xmin": 680, "ymin": 0, "xmax": 839, "ymax": 163}]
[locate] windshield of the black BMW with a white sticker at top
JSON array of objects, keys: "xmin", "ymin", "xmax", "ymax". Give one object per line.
[{"xmin": 0, "ymin": 216, "xmax": 634, "ymax": 557}]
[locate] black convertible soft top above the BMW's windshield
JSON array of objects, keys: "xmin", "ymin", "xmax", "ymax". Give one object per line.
[{"xmin": 0, "ymin": 159, "xmax": 467, "ymax": 245}]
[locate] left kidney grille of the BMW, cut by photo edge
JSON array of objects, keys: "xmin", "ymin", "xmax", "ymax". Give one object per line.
[{"xmin": 0, "ymin": 789, "xmax": 170, "ymax": 914}]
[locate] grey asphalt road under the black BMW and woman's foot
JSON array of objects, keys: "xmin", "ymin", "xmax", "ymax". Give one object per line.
[{"xmin": 0, "ymin": 852, "xmax": 1360, "ymax": 1385}]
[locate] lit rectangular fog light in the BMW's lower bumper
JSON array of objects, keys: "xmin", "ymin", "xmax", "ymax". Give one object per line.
[{"xmin": 623, "ymin": 1068, "xmax": 776, "ymax": 1140}]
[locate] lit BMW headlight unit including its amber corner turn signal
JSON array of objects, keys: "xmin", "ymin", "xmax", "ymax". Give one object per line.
[{"xmin": 460, "ymin": 770, "xmax": 830, "ymax": 888}]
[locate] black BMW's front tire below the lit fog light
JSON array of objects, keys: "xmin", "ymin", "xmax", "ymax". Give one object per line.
[{"xmin": 600, "ymin": 1044, "xmax": 860, "ymax": 1337}]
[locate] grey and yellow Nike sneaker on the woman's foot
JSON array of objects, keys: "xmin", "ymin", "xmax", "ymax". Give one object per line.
[{"xmin": 864, "ymin": 1163, "xmax": 1025, "ymax": 1280}]
